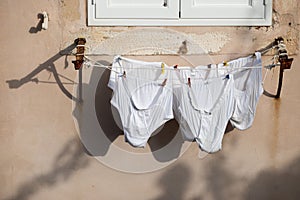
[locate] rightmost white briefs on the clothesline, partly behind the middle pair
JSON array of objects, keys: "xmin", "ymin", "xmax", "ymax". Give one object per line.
[{"xmin": 228, "ymin": 52, "xmax": 263, "ymax": 130}]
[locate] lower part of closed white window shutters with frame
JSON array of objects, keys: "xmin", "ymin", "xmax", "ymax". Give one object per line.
[{"xmin": 87, "ymin": 0, "xmax": 272, "ymax": 26}]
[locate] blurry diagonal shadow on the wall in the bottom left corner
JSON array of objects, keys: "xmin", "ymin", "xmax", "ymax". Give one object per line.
[{"xmin": 4, "ymin": 138, "xmax": 89, "ymax": 200}]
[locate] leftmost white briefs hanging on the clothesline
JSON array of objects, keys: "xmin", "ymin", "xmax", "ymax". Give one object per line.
[{"xmin": 108, "ymin": 57, "xmax": 174, "ymax": 147}]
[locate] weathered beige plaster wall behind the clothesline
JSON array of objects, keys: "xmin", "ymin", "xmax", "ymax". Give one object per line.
[{"xmin": 0, "ymin": 0, "xmax": 300, "ymax": 200}]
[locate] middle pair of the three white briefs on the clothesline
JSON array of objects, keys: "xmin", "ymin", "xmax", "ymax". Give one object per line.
[{"xmin": 174, "ymin": 68, "xmax": 234, "ymax": 152}]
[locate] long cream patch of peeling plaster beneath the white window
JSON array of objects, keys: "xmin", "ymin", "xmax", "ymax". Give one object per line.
[{"xmin": 90, "ymin": 28, "xmax": 230, "ymax": 55}]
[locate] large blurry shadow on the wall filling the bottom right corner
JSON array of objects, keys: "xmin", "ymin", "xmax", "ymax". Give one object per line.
[{"xmin": 204, "ymin": 154, "xmax": 300, "ymax": 200}]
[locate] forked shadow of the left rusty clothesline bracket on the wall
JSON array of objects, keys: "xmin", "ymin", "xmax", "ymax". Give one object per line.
[{"xmin": 6, "ymin": 43, "xmax": 79, "ymax": 101}]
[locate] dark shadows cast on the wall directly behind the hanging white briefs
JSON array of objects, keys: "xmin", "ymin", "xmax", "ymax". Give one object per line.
[{"xmin": 73, "ymin": 64, "xmax": 184, "ymax": 162}]
